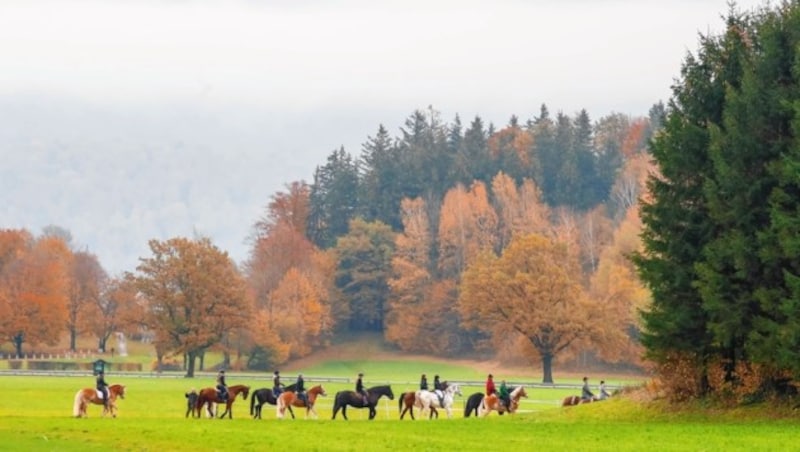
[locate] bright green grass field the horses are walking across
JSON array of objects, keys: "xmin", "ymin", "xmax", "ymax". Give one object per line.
[{"xmin": 0, "ymin": 361, "xmax": 800, "ymax": 451}]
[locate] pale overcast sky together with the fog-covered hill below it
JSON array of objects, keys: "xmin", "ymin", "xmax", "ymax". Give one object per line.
[{"xmin": 0, "ymin": 0, "xmax": 764, "ymax": 275}]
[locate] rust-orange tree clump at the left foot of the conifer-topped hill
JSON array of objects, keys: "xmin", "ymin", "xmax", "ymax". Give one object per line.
[{"xmin": 242, "ymin": 182, "xmax": 340, "ymax": 369}]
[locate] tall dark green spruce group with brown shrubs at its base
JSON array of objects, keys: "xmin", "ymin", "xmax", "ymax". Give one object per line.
[{"xmin": 636, "ymin": 1, "xmax": 800, "ymax": 401}]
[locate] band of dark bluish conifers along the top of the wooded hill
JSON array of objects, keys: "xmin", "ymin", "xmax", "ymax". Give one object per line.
[{"xmin": 308, "ymin": 103, "xmax": 664, "ymax": 247}]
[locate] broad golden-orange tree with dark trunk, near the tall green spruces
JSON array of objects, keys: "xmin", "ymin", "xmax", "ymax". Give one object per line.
[{"xmin": 458, "ymin": 234, "xmax": 596, "ymax": 383}]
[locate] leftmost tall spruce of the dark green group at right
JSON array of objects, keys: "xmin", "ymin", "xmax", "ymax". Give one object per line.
[{"xmin": 634, "ymin": 14, "xmax": 752, "ymax": 393}]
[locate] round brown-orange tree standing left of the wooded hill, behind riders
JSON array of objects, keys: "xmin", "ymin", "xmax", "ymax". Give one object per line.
[{"xmin": 135, "ymin": 238, "xmax": 252, "ymax": 377}]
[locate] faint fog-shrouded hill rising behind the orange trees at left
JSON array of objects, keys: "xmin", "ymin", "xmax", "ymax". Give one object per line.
[{"xmin": 0, "ymin": 99, "xmax": 394, "ymax": 274}]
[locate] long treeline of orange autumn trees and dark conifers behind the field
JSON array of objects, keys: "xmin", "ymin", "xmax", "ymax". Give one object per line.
[{"xmin": 0, "ymin": 104, "xmax": 664, "ymax": 381}]
